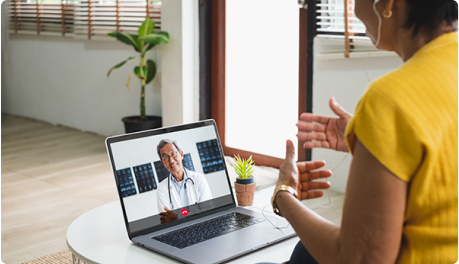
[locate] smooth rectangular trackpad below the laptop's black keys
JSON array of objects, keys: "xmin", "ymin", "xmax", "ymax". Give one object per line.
[{"xmin": 204, "ymin": 226, "xmax": 279, "ymax": 254}]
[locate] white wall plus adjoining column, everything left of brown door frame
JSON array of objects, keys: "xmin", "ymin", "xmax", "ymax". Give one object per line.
[{"xmin": 1, "ymin": 0, "xmax": 199, "ymax": 135}]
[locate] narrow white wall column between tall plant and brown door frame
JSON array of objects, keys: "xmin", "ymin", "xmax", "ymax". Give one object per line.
[{"xmin": 161, "ymin": 0, "xmax": 199, "ymax": 126}]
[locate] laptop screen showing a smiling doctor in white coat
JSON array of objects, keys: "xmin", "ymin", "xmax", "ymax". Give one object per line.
[{"xmin": 106, "ymin": 120, "xmax": 234, "ymax": 233}]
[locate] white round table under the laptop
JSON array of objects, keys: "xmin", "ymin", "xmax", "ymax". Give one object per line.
[{"xmin": 67, "ymin": 188, "xmax": 299, "ymax": 264}]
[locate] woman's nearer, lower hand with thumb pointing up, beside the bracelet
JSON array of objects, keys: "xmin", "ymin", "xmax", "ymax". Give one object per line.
[{"xmin": 277, "ymin": 140, "xmax": 332, "ymax": 200}]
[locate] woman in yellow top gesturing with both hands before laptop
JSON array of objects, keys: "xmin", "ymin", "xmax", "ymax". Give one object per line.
[{"xmin": 274, "ymin": 0, "xmax": 459, "ymax": 264}]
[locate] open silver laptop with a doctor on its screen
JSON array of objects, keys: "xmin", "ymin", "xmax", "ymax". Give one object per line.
[{"xmin": 106, "ymin": 120, "xmax": 296, "ymax": 263}]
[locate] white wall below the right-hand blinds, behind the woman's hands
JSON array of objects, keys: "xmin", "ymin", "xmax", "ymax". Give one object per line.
[{"xmin": 312, "ymin": 42, "xmax": 402, "ymax": 192}]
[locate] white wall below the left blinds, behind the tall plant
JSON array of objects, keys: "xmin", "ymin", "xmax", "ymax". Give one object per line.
[{"xmin": 1, "ymin": 3, "xmax": 161, "ymax": 135}]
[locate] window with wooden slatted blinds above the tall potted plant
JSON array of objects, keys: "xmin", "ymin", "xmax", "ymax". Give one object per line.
[{"xmin": 8, "ymin": 0, "xmax": 161, "ymax": 39}]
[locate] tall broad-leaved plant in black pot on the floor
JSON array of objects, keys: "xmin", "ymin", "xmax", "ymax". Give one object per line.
[{"xmin": 107, "ymin": 17, "xmax": 170, "ymax": 133}]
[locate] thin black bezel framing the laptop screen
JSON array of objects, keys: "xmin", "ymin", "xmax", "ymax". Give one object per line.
[{"xmin": 105, "ymin": 119, "xmax": 236, "ymax": 240}]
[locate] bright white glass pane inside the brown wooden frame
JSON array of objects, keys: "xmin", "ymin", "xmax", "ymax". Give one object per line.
[{"xmin": 226, "ymin": 0, "xmax": 299, "ymax": 162}]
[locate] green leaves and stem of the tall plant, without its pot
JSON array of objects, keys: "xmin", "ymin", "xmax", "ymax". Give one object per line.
[{"xmin": 107, "ymin": 17, "xmax": 170, "ymax": 120}]
